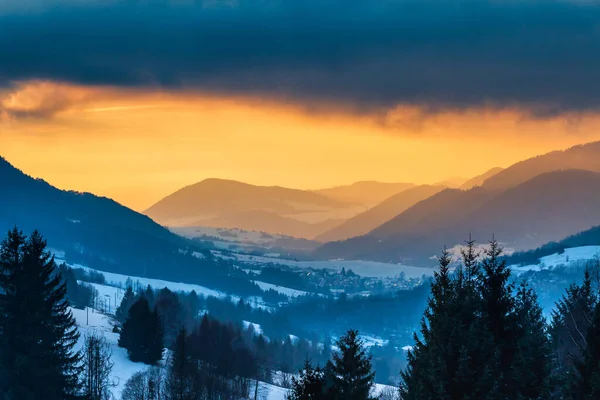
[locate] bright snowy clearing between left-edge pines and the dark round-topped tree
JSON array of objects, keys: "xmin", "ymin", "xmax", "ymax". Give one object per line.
[{"xmin": 71, "ymin": 308, "xmax": 148, "ymax": 399}]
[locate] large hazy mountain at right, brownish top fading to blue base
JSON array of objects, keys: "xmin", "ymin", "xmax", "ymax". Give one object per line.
[{"xmin": 315, "ymin": 170, "xmax": 600, "ymax": 263}]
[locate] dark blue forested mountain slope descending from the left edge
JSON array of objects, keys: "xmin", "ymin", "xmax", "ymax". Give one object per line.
[{"xmin": 0, "ymin": 158, "xmax": 256, "ymax": 292}]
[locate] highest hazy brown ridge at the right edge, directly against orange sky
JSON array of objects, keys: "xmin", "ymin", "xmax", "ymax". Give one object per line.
[{"xmin": 483, "ymin": 142, "xmax": 600, "ymax": 190}]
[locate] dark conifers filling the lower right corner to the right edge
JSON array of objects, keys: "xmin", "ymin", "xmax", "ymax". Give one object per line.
[{"xmin": 400, "ymin": 240, "xmax": 600, "ymax": 400}]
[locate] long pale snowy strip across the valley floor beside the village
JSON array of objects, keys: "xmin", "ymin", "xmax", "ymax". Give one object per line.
[{"xmin": 225, "ymin": 254, "xmax": 434, "ymax": 278}]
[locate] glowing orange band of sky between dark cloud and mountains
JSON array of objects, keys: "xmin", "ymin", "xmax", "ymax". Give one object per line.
[{"xmin": 0, "ymin": 82, "xmax": 600, "ymax": 210}]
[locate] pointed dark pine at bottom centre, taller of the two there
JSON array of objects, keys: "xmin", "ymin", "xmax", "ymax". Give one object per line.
[{"xmin": 332, "ymin": 330, "xmax": 375, "ymax": 400}]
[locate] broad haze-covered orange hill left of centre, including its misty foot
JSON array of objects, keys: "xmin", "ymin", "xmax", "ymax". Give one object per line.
[{"xmin": 145, "ymin": 179, "xmax": 364, "ymax": 234}]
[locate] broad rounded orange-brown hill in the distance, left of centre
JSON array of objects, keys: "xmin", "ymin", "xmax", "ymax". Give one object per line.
[{"xmin": 144, "ymin": 179, "xmax": 356, "ymax": 233}]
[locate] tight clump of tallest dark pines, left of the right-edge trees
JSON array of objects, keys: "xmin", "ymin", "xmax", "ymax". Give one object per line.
[{"xmin": 401, "ymin": 239, "xmax": 549, "ymax": 400}]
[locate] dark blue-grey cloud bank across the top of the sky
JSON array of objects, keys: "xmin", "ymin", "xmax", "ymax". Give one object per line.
[{"xmin": 0, "ymin": 0, "xmax": 600, "ymax": 116}]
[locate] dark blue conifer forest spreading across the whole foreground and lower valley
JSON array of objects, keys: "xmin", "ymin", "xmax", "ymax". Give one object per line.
[{"xmin": 0, "ymin": 228, "xmax": 600, "ymax": 400}]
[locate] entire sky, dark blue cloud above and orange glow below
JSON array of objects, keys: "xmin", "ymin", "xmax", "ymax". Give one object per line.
[{"xmin": 0, "ymin": 0, "xmax": 600, "ymax": 211}]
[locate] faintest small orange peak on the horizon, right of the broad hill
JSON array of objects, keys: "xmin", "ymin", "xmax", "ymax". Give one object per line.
[{"xmin": 315, "ymin": 181, "xmax": 415, "ymax": 208}]
